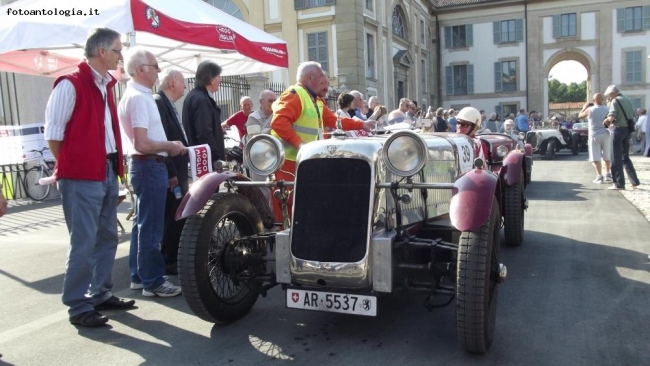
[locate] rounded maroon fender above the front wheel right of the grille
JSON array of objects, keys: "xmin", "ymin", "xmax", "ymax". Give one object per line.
[{"xmin": 449, "ymin": 169, "xmax": 499, "ymax": 231}]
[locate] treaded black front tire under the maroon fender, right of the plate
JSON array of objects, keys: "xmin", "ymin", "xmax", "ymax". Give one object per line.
[{"xmin": 456, "ymin": 198, "xmax": 501, "ymax": 353}]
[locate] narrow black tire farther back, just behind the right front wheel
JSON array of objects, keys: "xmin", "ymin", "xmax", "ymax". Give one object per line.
[{"xmin": 503, "ymin": 172, "xmax": 524, "ymax": 247}]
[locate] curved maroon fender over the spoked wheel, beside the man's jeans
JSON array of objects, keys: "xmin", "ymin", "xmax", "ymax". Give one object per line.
[{"xmin": 175, "ymin": 171, "xmax": 250, "ymax": 220}]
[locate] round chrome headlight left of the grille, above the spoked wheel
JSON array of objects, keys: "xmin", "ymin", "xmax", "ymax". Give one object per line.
[{"xmin": 244, "ymin": 135, "xmax": 284, "ymax": 176}]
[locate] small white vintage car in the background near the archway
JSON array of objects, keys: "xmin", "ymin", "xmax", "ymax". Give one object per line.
[{"xmin": 526, "ymin": 128, "xmax": 580, "ymax": 160}]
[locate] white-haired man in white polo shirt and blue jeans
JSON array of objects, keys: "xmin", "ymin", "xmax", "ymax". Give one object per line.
[{"xmin": 117, "ymin": 47, "xmax": 187, "ymax": 297}]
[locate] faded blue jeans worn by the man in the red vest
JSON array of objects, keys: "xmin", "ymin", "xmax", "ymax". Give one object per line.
[{"xmin": 59, "ymin": 161, "xmax": 118, "ymax": 316}]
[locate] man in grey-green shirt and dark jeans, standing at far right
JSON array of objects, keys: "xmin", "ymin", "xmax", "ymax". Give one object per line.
[{"xmin": 603, "ymin": 85, "xmax": 641, "ymax": 190}]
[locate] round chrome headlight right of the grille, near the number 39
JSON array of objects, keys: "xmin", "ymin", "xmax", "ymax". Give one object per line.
[{"xmin": 383, "ymin": 130, "xmax": 427, "ymax": 177}]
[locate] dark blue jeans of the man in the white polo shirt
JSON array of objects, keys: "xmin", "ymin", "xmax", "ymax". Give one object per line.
[{"xmin": 129, "ymin": 160, "xmax": 168, "ymax": 291}]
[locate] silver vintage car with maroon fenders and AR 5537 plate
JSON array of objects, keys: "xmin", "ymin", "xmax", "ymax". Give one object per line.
[{"xmin": 176, "ymin": 130, "xmax": 528, "ymax": 353}]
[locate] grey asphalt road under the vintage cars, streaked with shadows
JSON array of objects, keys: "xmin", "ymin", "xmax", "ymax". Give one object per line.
[{"xmin": 0, "ymin": 153, "xmax": 650, "ymax": 366}]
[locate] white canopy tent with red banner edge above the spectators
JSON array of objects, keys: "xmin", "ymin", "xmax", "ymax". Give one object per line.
[{"xmin": 0, "ymin": 0, "xmax": 288, "ymax": 77}]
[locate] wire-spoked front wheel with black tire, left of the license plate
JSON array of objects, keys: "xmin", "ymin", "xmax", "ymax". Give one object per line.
[{"xmin": 178, "ymin": 193, "xmax": 263, "ymax": 323}]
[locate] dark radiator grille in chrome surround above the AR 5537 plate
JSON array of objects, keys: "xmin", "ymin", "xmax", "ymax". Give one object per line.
[{"xmin": 291, "ymin": 158, "xmax": 371, "ymax": 262}]
